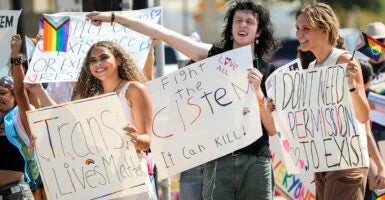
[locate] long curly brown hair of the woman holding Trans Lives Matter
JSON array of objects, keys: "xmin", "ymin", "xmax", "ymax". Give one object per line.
[{"xmin": 72, "ymin": 41, "xmax": 146, "ymax": 100}]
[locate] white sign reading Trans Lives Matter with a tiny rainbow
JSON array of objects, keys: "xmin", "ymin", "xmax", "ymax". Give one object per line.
[{"xmin": 27, "ymin": 93, "xmax": 149, "ymax": 199}]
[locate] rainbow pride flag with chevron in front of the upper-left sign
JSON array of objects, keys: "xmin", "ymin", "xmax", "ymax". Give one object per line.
[{"xmin": 43, "ymin": 15, "xmax": 70, "ymax": 52}]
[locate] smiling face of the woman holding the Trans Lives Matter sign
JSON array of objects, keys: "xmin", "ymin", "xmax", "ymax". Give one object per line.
[{"xmin": 89, "ymin": 46, "xmax": 120, "ymax": 81}]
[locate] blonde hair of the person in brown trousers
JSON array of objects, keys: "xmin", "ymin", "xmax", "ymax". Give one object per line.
[{"xmin": 295, "ymin": 3, "xmax": 346, "ymax": 49}]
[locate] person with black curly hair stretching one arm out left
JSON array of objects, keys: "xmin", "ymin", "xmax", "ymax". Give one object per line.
[{"xmin": 87, "ymin": 0, "xmax": 277, "ymax": 199}]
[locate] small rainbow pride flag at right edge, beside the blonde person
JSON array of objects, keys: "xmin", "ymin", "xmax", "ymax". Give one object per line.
[{"xmin": 356, "ymin": 32, "xmax": 385, "ymax": 61}]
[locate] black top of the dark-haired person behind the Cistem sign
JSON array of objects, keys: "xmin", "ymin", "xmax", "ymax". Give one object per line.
[{"xmin": 208, "ymin": 45, "xmax": 277, "ymax": 157}]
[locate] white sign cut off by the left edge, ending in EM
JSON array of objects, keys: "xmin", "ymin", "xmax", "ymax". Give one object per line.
[{"xmin": 0, "ymin": 10, "xmax": 21, "ymax": 74}]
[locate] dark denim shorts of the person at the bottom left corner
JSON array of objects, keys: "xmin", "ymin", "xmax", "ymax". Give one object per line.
[{"xmin": 0, "ymin": 181, "xmax": 33, "ymax": 200}]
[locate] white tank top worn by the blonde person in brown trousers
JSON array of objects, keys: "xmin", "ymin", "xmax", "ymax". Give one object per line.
[{"xmin": 308, "ymin": 48, "xmax": 369, "ymax": 165}]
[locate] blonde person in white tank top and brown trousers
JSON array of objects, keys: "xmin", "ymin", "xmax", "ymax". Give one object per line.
[{"xmin": 295, "ymin": 3, "xmax": 369, "ymax": 200}]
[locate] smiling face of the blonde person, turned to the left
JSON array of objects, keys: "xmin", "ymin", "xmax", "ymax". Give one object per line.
[{"xmin": 295, "ymin": 13, "xmax": 327, "ymax": 52}]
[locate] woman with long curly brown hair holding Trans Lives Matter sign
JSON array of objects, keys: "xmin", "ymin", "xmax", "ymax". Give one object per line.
[{"xmin": 72, "ymin": 41, "xmax": 157, "ymax": 199}]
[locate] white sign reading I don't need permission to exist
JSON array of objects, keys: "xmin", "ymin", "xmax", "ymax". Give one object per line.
[{"xmin": 272, "ymin": 64, "xmax": 369, "ymax": 173}]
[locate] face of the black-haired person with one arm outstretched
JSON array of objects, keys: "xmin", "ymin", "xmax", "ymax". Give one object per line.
[{"xmin": 231, "ymin": 10, "xmax": 260, "ymax": 48}]
